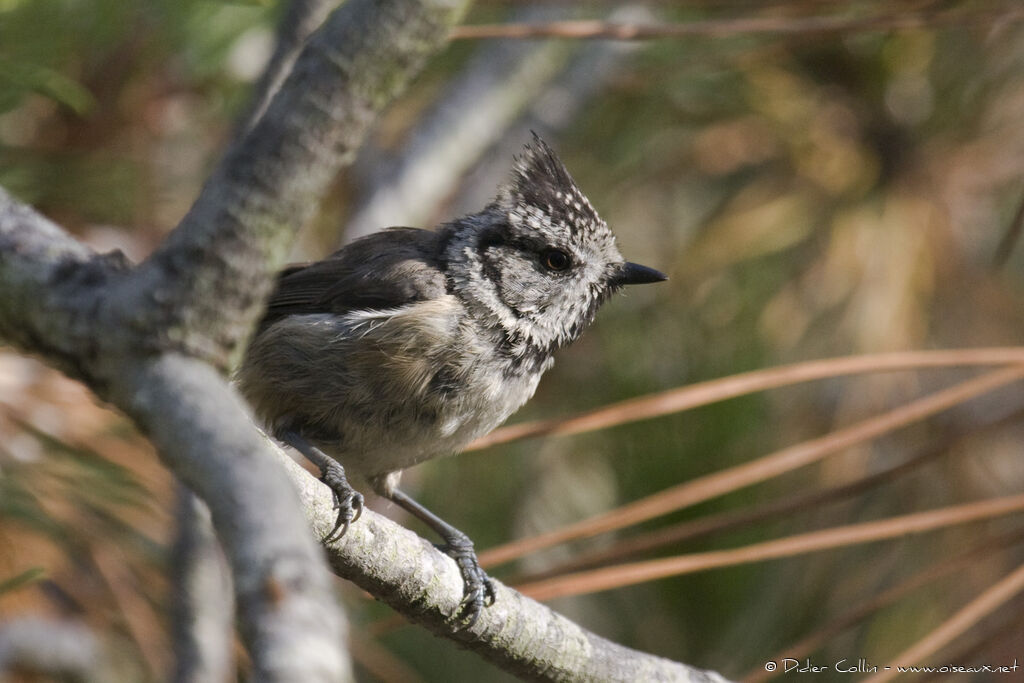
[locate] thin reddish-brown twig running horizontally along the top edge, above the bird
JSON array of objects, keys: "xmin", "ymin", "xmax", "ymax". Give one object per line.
[{"xmin": 452, "ymin": 7, "xmax": 1024, "ymax": 40}]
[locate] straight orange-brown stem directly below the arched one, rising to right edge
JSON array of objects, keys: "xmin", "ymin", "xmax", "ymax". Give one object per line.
[{"xmin": 480, "ymin": 366, "xmax": 1024, "ymax": 565}]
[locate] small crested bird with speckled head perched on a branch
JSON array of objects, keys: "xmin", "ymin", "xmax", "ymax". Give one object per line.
[{"xmin": 237, "ymin": 133, "xmax": 667, "ymax": 628}]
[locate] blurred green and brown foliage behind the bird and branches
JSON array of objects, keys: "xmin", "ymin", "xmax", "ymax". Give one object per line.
[{"xmin": 0, "ymin": 0, "xmax": 1024, "ymax": 681}]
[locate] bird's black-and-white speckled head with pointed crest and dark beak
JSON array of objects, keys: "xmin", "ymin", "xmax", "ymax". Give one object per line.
[{"xmin": 445, "ymin": 134, "xmax": 666, "ymax": 366}]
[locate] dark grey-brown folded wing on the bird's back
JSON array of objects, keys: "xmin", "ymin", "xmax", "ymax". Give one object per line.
[{"xmin": 260, "ymin": 227, "xmax": 446, "ymax": 328}]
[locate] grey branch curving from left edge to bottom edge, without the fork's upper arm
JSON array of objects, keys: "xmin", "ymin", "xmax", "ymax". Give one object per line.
[{"xmin": 0, "ymin": 189, "xmax": 348, "ymax": 681}]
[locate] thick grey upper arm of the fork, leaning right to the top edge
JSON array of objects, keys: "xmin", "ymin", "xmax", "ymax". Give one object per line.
[{"xmin": 118, "ymin": 0, "xmax": 468, "ymax": 369}]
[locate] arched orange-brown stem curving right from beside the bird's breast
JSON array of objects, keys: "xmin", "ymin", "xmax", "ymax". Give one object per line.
[{"xmin": 466, "ymin": 346, "xmax": 1024, "ymax": 451}]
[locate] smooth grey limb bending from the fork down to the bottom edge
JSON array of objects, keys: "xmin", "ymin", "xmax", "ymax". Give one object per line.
[{"xmin": 110, "ymin": 352, "xmax": 350, "ymax": 681}]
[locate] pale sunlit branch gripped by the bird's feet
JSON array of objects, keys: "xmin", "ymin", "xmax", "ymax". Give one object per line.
[{"xmin": 278, "ymin": 440, "xmax": 726, "ymax": 683}]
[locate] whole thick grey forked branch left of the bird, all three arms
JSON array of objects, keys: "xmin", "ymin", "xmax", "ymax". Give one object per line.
[{"xmin": 0, "ymin": 0, "xmax": 465, "ymax": 681}]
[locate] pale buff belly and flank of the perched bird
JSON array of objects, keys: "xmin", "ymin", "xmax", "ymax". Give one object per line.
[{"xmin": 241, "ymin": 296, "xmax": 543, "ymax": 480}]
